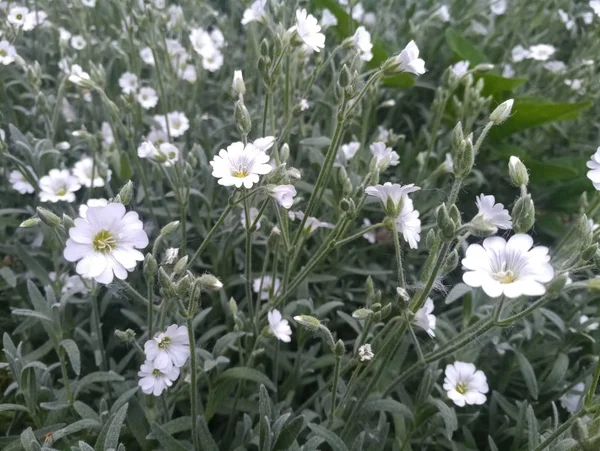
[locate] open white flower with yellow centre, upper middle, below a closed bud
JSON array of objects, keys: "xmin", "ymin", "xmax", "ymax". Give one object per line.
[{"xmin": 210, "ymin": 141, "xmax": 273, "ymax": 189}]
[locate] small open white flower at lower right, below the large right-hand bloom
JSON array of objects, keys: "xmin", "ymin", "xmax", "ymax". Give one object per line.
[{"xmin": 444, "ymin": 362, "xmax": 489, "ymax": 407}]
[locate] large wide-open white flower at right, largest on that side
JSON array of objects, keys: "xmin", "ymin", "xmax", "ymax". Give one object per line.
[{"xmin": 462, "ymin": 233, "xmax": 554, "ymax": 298}]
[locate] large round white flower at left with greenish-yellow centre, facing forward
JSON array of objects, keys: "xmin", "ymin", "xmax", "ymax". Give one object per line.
[{"xmin": 63, "ymin": 203, "xmax": 148, "ymax": 284}]
